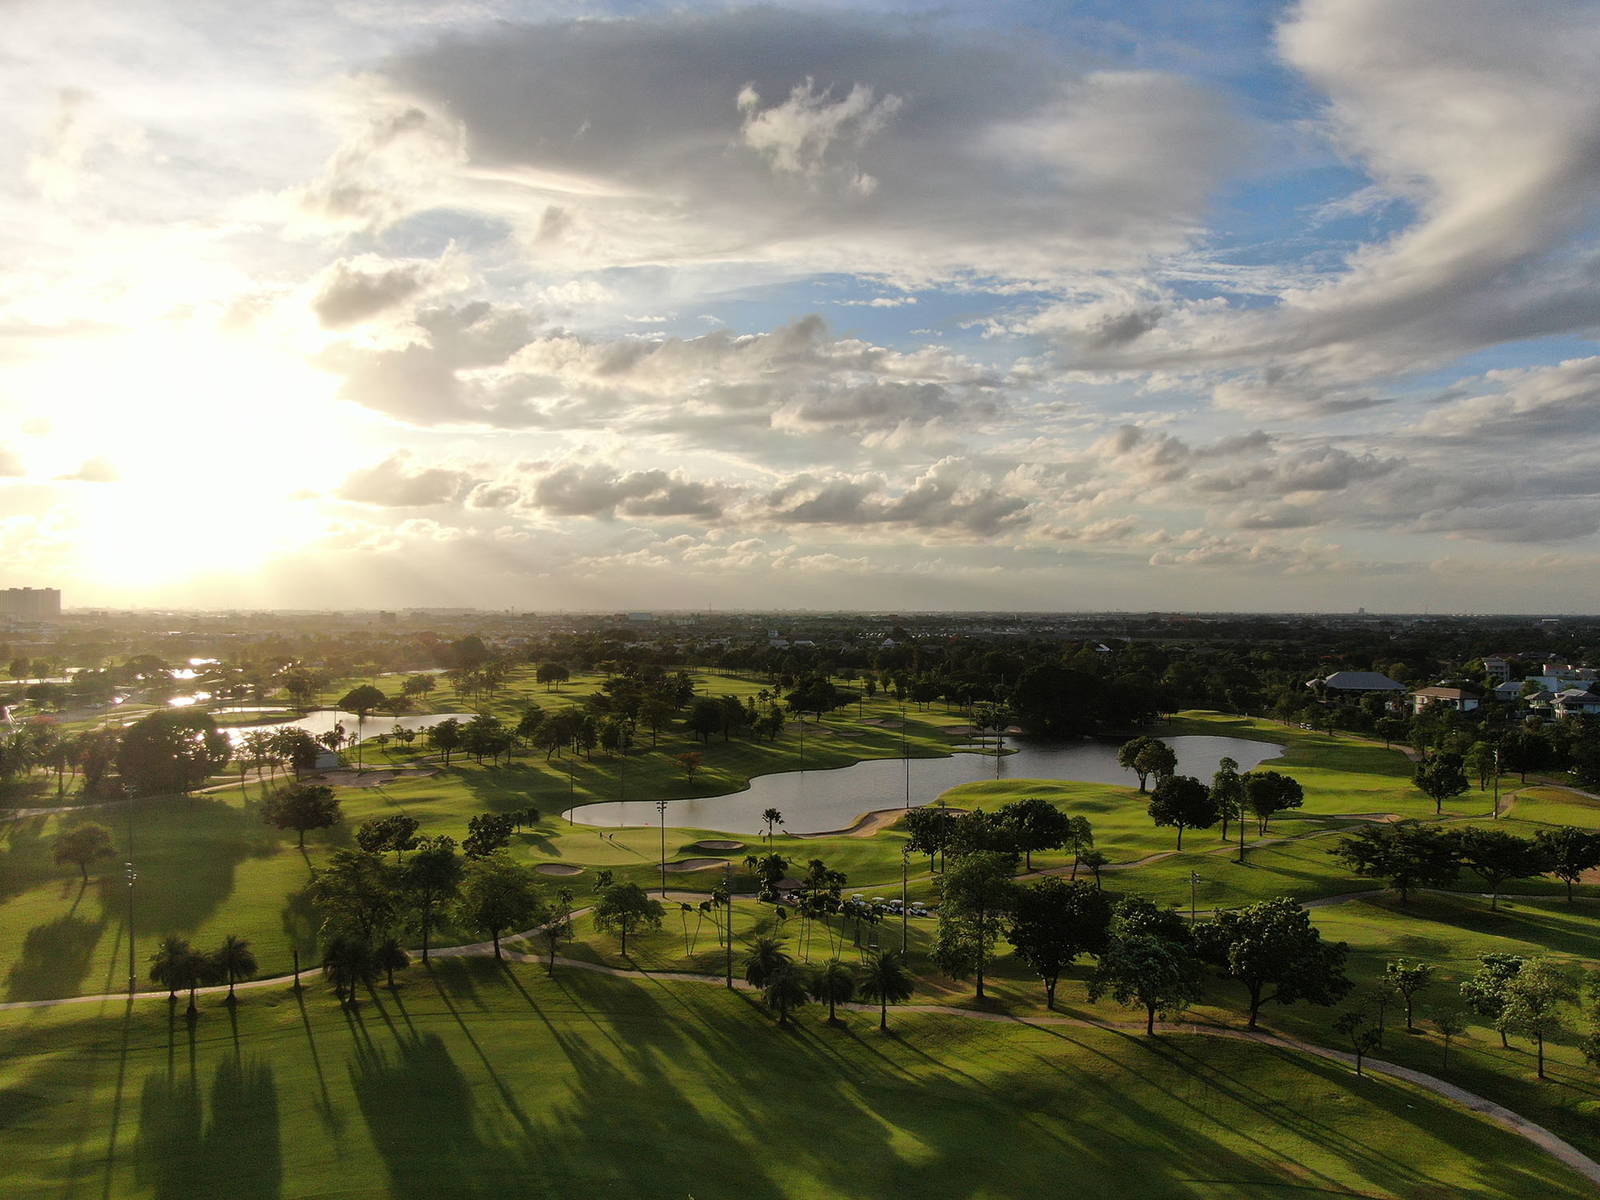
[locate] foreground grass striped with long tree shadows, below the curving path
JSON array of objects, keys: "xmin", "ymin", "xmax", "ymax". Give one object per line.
[{"xmin": 0, "ymin": 962, "xmax": 1592, "ymax": 1200}]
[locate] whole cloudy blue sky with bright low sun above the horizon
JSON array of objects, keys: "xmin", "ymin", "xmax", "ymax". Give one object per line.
[{"xmin": 0, "ymin": 0, "xmax": 1600, "ymax": 613}]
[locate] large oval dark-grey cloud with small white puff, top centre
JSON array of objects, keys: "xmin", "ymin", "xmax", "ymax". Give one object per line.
[{"xmin": 360, "ymin": 8, "xmax": 1251, "ymax": 280}]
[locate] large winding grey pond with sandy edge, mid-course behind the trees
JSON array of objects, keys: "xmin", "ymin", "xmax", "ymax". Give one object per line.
[{"xmin": 566, "ymin": 736, "xmax": 1282, "ymax": 834}]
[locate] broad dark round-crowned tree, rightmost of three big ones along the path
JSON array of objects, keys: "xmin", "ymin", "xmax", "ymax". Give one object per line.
[{"xmin": 1195, "ymin": 896, "xmax": 1350, "ymax": 1029}]
